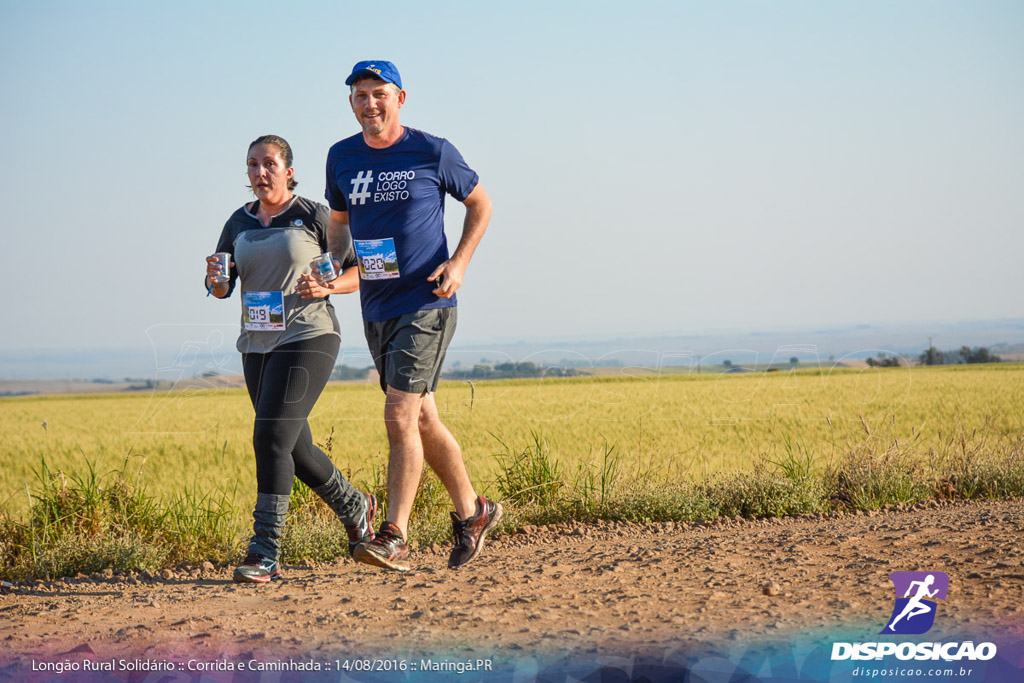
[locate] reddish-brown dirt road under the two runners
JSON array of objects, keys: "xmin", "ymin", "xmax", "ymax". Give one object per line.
[{"xmin": 0, "ymin": 502, "xmax": 1024, "ymax": 680}]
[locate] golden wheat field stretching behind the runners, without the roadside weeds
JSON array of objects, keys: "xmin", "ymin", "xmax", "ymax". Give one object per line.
[{"xmin": 0, "ymin": 364, "xmax": 1024, "ymax": 513}]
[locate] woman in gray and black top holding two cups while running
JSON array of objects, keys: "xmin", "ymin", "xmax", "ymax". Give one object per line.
[{"xmin": 206, "ymin": 135, "xmax": 377, "ymax": 584}]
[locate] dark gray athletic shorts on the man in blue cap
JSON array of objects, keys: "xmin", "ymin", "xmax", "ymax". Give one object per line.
[{"xmin": 362, "ymin": 306, "xmax": 459, "ymax": 393}]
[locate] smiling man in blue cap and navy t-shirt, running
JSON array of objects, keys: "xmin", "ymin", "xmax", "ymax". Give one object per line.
[{"xmin": 311, "ymin": 60, "xmax": 502, "ymax": 569}]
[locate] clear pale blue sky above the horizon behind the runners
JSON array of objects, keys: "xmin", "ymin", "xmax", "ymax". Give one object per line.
[{"xmin": 0, "ymin": 0, "xmax": 1024, "ymax": 358}]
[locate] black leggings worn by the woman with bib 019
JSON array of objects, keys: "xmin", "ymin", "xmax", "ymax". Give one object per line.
[{"xmin": 242, "ymin": 335, "xmax": 341, "ymax": 496}]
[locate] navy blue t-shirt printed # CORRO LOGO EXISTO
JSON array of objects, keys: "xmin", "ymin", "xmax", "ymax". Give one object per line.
[{"xmin": 324, "ymin": 127, "xmax": 479, "ymax": 323}]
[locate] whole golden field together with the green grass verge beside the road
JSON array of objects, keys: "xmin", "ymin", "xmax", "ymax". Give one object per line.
[{"xmin": 0, "ymin": 364, "xmax": 1024, "ymax": 580}]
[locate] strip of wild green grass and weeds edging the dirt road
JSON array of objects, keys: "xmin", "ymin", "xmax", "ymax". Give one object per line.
[{"xmin": 0, "ymin": 423, "xmax": 1024, "ymax": 581}]
